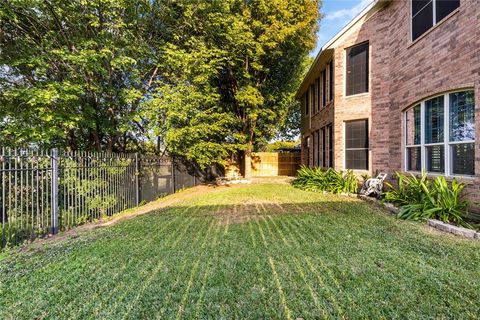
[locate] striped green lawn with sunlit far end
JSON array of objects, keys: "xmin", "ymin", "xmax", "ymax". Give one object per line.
[{"xmin": 0, "ymin": 184, "xmax": 480, "ymax": 319}]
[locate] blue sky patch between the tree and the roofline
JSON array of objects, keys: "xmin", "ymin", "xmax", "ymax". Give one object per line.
[{"xmin": 312, "ymin": 0, "xmax": 373, "ymax": 56}]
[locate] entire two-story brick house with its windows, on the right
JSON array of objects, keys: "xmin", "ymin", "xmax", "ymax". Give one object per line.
[{"xmin": 297, "ymin": 0, "xmax": 480, "ymax": 202}]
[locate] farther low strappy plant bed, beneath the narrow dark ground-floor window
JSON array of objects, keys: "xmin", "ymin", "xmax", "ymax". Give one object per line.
[{"xmin": 292, "ymin": 166, "xmax": 358, "ymax": 193}]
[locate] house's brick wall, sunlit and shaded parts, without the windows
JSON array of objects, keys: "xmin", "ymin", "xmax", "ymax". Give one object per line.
[{"xmin": 302, "ymin": 0, "xmax": 480, "ymax": 201}]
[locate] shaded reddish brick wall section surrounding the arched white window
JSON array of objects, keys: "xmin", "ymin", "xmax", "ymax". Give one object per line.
[{"xmin": 386, "ymin": 0, "xmax": 480, "ymax": 201}]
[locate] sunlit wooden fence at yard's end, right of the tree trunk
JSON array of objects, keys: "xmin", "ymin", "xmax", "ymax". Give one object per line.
[{"xmin": 252, "ymin": 152, "xmax": 301, "ymax": 177}]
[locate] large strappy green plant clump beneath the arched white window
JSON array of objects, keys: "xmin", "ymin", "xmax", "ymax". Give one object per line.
[{"xmin": 384, "ymin": 172, "xmax": 468, "ymax": 225}]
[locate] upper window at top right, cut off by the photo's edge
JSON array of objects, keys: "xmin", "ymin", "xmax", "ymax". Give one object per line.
[{"xmin": 412, "ymin": 0, "xmax": 460, "ymax": 40}]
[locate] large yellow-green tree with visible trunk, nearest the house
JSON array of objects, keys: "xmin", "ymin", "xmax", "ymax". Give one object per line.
[{"xmin": 146, "ymin": 0, "xmax": 320, "ymax": 178}]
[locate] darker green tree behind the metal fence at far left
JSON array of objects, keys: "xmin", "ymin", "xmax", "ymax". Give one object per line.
[{"xmin": 0, "ymin": 0, "xmax": 171, "ymax": 151}]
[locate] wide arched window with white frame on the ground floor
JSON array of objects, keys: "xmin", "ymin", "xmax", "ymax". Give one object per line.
[{"xmin": 404, "ymin": 90, "xmax": 475, "ymax": 176}]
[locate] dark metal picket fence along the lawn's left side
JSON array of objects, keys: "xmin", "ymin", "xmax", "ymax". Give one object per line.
[{"xmin": 0, "ymin": 148, "xmax": 207, "ymax": 247}]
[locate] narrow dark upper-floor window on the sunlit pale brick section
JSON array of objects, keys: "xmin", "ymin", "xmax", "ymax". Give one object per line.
[{"xmin": 345, "ymin": 42, "xmax": 368, "ymax": 96}]
